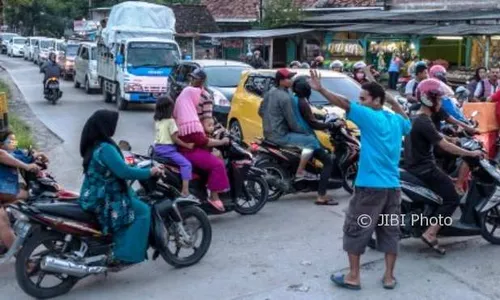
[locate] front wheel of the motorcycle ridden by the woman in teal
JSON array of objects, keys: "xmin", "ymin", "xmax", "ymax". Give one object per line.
[{"xmin": 160, "ymin": 206, "xmax": 212, "ymax": 268}]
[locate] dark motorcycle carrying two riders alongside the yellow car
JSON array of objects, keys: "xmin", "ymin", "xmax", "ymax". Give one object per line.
[{"xmin": 251, "ymin": 114, "xmax": 360, "ymax": 201}]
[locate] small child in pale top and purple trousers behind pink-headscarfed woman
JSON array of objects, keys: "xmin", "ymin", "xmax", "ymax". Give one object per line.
[{"xmin": 154, "ymin": 96, "xmax": 195, "ymax": 200}]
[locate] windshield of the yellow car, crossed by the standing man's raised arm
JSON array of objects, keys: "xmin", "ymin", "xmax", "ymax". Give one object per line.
[{"xmin": 309, "ymin": 78, "xmax": 361, "ymax": 105}]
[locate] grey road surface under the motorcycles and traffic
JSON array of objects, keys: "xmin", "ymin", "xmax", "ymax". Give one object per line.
[{"xmin": 0, "ymin": 56, "xmax": 500, "ymax": 300}]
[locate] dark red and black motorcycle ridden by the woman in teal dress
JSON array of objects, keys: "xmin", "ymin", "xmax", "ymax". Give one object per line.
[{"xmin": 9, "ymin": 161, "xmax": 212, "ymax": 299}]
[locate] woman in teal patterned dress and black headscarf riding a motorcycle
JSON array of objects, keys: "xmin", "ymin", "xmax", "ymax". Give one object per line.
[{"xmin": 79, "ymin": 110, "xmax": 161, "ymax": 264}]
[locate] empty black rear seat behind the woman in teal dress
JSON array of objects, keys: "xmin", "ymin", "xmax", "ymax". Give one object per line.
[{"xmin": 33, "ymin": 202, "xmax": 97, "ymax": 223}]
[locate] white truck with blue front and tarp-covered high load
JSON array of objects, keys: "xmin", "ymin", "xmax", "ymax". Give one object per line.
[{"xmin": 97, "ymin": 1, "xmax": 181, "ymax": 110}]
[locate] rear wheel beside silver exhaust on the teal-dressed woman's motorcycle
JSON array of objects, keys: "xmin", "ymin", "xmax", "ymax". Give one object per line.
[{"xmin": 16, "ymin": 231, "xmax": 78, "ymax": 299}]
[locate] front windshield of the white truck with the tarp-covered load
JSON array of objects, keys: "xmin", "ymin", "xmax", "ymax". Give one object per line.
[{"xmin": 127, "ymin": 42, "xmax": 179, "ymax": 67}]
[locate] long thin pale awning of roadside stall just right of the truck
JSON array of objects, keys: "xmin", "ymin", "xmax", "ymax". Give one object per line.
[{"xmin": 200, "ymin": 28, "xmax": 315, "ymax": 39}]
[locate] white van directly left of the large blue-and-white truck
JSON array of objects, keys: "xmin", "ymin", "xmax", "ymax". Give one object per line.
[{"xmin": 74, "ymin": 43, "xmax": 101, "ymax": 94}]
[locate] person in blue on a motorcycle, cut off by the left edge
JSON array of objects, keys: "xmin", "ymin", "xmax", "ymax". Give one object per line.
[{"xmin": 0, "ymin": 130, "xmax": 46, "ymax": 254}]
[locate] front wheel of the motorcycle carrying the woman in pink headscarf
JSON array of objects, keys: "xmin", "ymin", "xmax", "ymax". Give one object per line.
[{"xmin": 234, "ymin": 177, "xmax": 269, "ymax": 215}]
